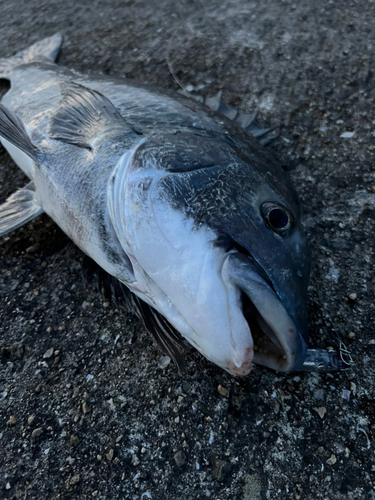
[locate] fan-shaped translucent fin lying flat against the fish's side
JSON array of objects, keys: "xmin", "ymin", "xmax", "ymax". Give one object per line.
[{"xmin": 49, "ymin": 84, "xmax": 141, "ymax": 150}]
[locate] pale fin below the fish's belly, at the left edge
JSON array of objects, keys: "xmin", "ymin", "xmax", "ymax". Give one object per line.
[{"xmin": 0, "ymin": 182, "xmax": 43, "ymax": 236}]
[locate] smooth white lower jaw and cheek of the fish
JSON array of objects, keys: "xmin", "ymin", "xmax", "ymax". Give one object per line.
[{"xmin": 127, "ymin": 207, "xmax": 253, "ymax": 376}]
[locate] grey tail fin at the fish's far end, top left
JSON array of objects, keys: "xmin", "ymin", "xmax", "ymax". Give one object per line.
[{"xmin": 0, "ymin": 34, "xmax": 62, "ymax": 79}]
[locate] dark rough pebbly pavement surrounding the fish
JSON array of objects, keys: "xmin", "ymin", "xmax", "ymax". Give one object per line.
[{"xmin": 0, "ymin": 0, "xmax": 375, "ymax": 500}]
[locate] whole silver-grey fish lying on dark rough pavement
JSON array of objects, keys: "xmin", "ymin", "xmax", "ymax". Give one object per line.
[{"xmin": 0, "ymin": 34, "xmax": 350, "ymax": 376}]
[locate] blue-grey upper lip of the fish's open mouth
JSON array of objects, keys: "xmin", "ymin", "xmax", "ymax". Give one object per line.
[{"xmin": 227, "ymin": 252, "xmax": 307, "ymax": 373}]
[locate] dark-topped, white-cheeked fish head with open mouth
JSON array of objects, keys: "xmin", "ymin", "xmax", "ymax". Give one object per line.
[{"xmin": 110, "ymin": 134, "xmax": 310, "ymax": 375}]
